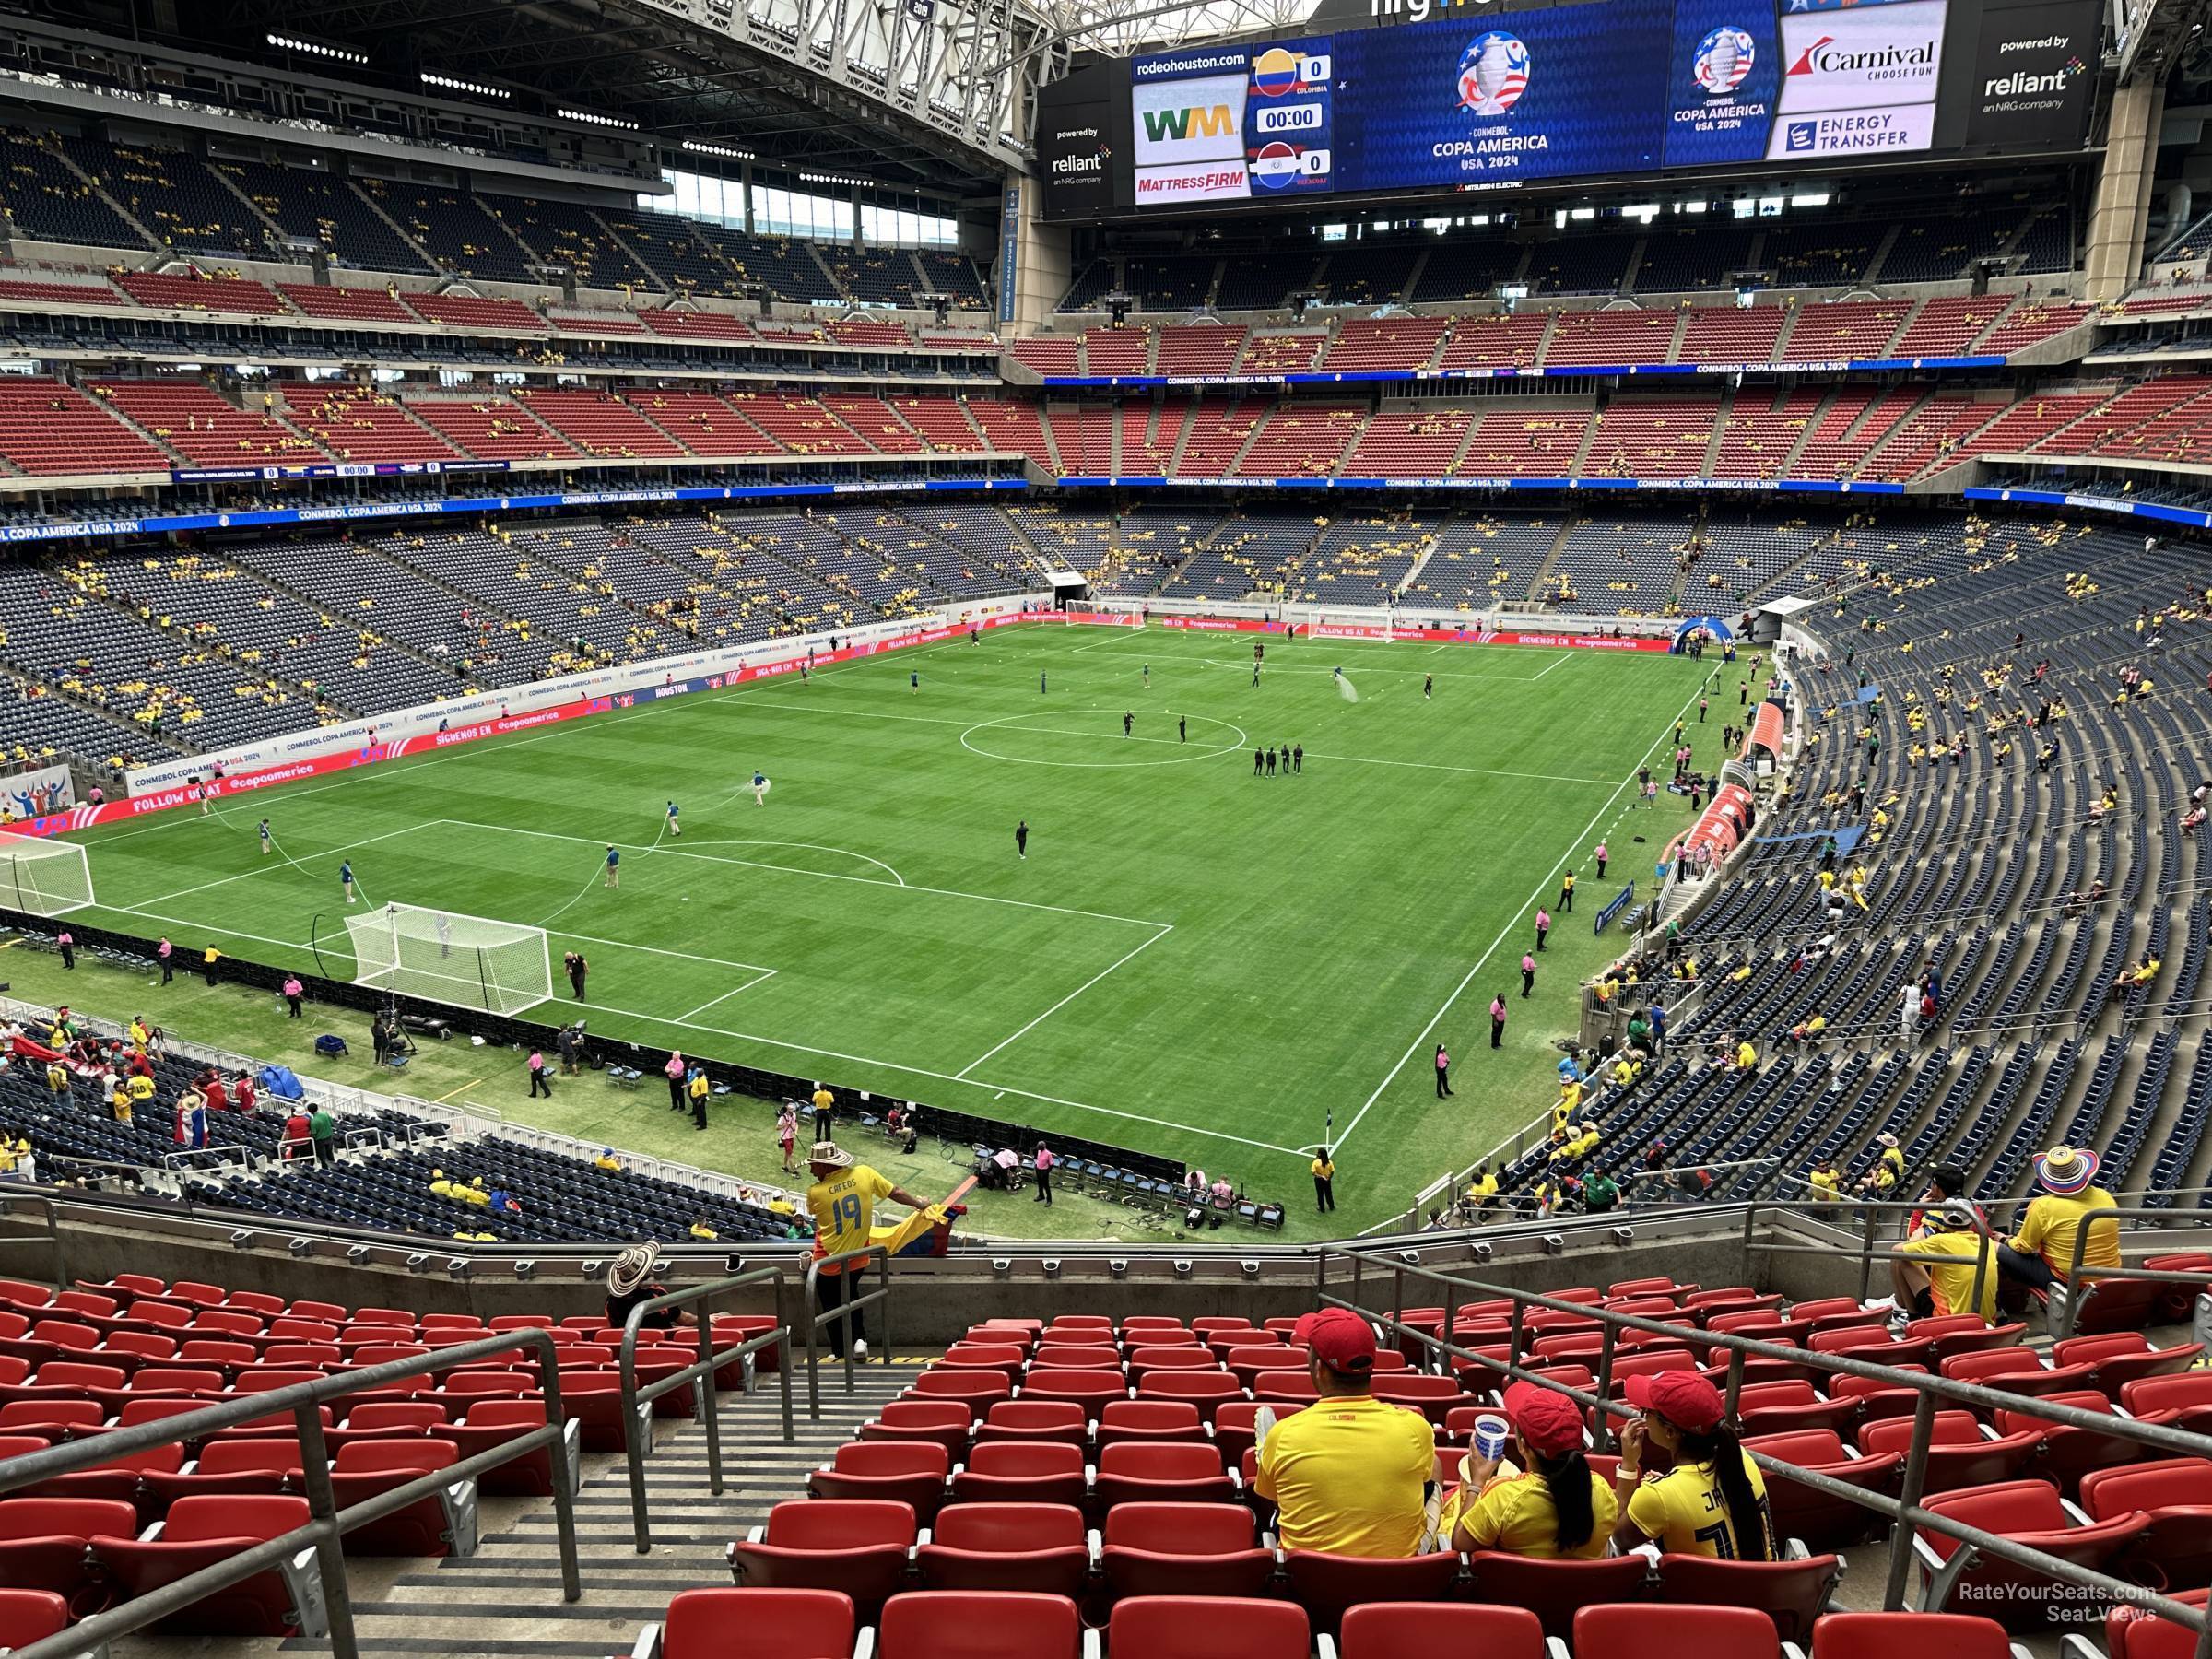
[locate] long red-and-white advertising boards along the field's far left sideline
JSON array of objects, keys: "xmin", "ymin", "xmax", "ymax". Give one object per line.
[{"xmin": 100, "ymin": 602, "xmax": 1065, "ymax": 836}]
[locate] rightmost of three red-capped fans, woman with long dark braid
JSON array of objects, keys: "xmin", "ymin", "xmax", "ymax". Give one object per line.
[{"xmin": 1613, "ymin": 1371, "xmax": 1781, "ymax": 1561}]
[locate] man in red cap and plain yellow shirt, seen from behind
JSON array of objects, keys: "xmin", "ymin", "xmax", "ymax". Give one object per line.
[{"xmin": 1252, "ymin": 1307, "xmax": 1436, "ymax": 1558}]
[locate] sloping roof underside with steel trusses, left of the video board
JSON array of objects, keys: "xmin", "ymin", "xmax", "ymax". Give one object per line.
[{"xmin": 207, "ymin": 0, "xmax": 1026, "ymax": 193}]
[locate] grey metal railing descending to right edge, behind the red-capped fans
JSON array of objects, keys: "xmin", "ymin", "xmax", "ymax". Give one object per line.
[{"xmin": 1316, "ymin": 1248, "xmax": 2212, "ymax": 1659}]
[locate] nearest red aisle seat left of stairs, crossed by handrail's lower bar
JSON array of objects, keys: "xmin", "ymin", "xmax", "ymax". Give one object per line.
[{"xmin": 93, "ymin": 1498, "xmax": 323, "ymax": 1637}]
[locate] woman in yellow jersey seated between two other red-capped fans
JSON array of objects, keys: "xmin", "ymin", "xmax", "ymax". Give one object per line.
[{"xmin": 1451, "ymin": 1382, "xmax": 1619, "ymax": 1559}]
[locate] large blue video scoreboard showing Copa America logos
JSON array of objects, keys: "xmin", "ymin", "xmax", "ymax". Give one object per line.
[{"xmin": 1038, "ymin": 0, "xmax": 2101, "ymax": 219}]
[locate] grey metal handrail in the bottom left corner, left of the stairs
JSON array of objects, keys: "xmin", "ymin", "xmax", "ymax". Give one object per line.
[{"xmin": 0, "ymin": 1329, "xmax": 584, "ymax": 1659}]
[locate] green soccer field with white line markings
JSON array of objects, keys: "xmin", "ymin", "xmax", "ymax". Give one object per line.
[{"xmin": 52, "ymin": 626, "xmax": 1707, "ymax": 1223}]
